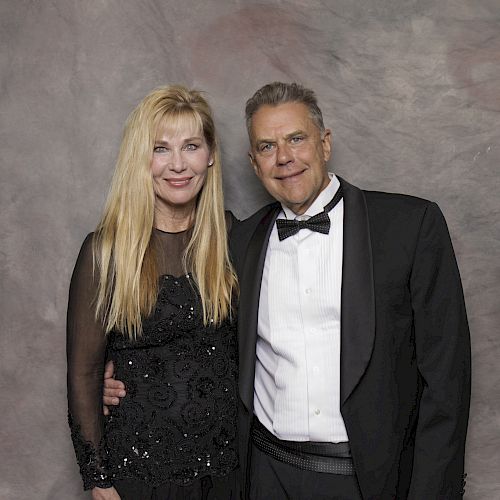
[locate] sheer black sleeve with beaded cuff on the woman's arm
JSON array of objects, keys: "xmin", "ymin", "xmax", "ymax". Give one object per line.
[{"xmin": 66, "ymin": 234, "xmax": 111, "ymax": 489}]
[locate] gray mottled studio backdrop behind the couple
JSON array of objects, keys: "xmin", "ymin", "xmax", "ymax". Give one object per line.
[{"xmin": 0, "ymin": 0, "xmax": 500, "ymax": 500}]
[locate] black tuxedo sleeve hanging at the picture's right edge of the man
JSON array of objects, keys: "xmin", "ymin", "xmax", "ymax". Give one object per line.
[{"xmin": 408, "ymin": 203, "xmax": 470, "ymax": 500}]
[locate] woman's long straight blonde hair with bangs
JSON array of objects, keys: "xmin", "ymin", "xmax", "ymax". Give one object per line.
[{"xmin": 93, "ymin": 85, "xmax": 237, "ymax": 339}]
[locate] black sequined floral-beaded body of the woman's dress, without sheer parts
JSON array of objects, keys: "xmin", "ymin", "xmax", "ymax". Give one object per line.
[{"xmin": 101, "ymin": 275, "xmax": 238, "ymax": 485}]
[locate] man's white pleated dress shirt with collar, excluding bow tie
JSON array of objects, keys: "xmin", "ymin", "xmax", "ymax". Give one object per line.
[{"xmin": 254, "ymin": 174, "xmax": 348, "ymax": 443}]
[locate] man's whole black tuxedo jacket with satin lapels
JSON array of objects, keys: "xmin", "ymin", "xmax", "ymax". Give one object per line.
[{"xmin": 230, "ymin": 178, "xmax": 470, "ymax": 500}]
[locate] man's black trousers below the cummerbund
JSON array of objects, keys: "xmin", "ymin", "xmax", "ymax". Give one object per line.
[{"xmin": 250, "ymin": 444, "xmax": 362, "ymax": 500}]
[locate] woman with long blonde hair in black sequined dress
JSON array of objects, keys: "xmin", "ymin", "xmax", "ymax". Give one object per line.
[{"xmin": 67, "ymin": 86, "xmax": 238, "ymax": 500}]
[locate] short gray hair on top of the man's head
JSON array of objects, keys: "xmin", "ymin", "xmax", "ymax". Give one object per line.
[{"xmin": 245, "ymin": 82, "xmax": 325, "ymax": 134}]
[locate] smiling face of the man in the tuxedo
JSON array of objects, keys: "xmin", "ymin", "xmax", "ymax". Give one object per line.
[{"xmin": 249, "ymin": 102, "xmax": 331, "ymax": 215}]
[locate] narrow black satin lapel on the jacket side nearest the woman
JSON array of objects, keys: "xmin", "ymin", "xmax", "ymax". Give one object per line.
[{"xmin": 238, "ymin": 203, "xmax": 281, "ymax": 411}]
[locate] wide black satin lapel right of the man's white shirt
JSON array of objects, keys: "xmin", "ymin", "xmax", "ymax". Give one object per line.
[{"xmin": 339, "ymin": 177, "xmax": 375, "ymax": 404}]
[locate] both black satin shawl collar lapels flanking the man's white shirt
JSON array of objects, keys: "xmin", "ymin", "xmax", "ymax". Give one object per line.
[{"xmin": 238, "ymin": 177, "xmax": 375, "ymax": 411}]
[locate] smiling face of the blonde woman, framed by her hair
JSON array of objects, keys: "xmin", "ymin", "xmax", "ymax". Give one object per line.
[{"xmin": 151, "ymin": 124, "xmax": 213, "ymax": 218}]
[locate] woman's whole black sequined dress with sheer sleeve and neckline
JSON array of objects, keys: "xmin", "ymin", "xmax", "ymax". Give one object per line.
[{"xmin": 67, "ymin": 229, "xmax": 239, "ymax": 500}]
